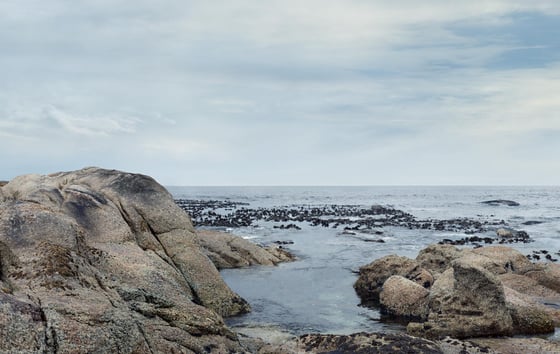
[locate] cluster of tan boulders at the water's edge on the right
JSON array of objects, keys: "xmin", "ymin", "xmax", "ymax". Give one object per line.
[{"xmin": 354, "ymin": 245, "xmax": 560, "ymax": 339}]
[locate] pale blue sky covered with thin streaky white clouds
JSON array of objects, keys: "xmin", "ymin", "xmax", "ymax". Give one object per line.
[{"xmin": 0, "ymin": 0, "xmax": 560, "ymax": 186}]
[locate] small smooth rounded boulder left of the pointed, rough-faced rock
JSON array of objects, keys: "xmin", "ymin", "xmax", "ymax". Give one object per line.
[{"xmin": 380, "ymin": 275, "xmax": 430, "ymax": 320}]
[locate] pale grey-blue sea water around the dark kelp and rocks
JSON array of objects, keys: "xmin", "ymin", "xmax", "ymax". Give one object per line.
[{"xmin": 168, "ymin": 186, "xmax": 560, "ymax": 334}]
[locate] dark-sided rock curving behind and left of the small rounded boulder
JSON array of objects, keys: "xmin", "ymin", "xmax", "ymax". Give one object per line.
[{"xmin": 354, "ymin": 255, "xmax": 433, "ymax": 305}]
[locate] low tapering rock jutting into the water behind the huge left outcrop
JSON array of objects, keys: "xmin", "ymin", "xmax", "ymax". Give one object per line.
[{"xmin": 197, "ymin": 230, "xmax": 294, "ymax": 269}]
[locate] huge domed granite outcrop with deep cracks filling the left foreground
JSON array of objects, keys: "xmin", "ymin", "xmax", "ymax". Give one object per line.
[{"xmin": 0, "ymin": 168, "xmax": 249, "ymax": 353}]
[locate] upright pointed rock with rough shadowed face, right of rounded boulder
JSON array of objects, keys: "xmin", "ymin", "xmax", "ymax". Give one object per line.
[{"xmin": 407, "ymin": 258, "xmax": 513, "ymax": 338}]
